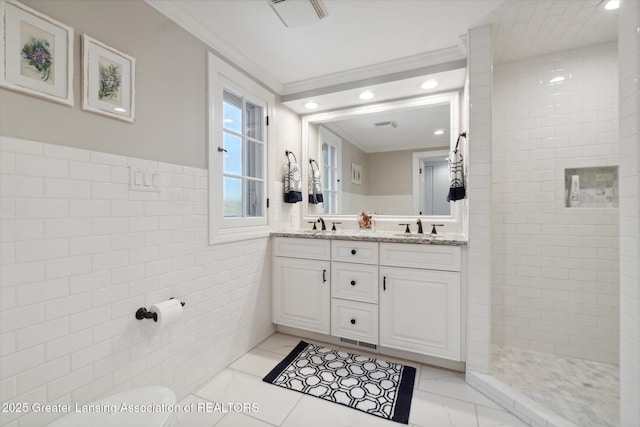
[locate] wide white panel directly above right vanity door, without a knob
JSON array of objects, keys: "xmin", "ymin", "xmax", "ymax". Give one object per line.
[{"xmin": 380, "ymin": 243, "xmax": 460, "ymax": 271}]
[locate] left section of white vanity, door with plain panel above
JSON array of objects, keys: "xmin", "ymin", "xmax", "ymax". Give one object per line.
[{"xmin": 273, "ymin": 237, "xmax": 331, "ymax": 334}]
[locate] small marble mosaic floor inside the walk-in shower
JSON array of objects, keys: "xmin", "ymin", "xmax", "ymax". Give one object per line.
[{"xmin": 491, "ymin": 346, "xmax": 620, "ymax": 427}]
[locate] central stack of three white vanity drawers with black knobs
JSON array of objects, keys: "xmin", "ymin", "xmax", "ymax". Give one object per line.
[{"xmin": 331, "ymin": 240, "xmax": 378, "ymax": 344}]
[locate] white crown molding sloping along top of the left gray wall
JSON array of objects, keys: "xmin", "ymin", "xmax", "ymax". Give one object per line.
[{"xmin": 145, "ymin": 0, "xmax": 283, "ymax": 94}]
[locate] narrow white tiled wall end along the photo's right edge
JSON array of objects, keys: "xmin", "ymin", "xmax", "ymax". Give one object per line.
[{"xmin": 618, "ymin": 1, "xmax": 640, "ymax": 426}]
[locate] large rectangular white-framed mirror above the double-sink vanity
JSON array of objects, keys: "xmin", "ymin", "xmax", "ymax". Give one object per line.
[{"xmin": 302, "ymin": 92, "xmax": 460, "ymax": 222}]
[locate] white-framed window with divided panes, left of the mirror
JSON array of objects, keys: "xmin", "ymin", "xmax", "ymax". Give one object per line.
[{"xmin": 209, "ymin": 54, "xmax": 274, "ymax": 243}]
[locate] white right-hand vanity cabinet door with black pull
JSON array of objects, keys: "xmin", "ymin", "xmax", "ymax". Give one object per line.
[{"xmin": 380, "ymin": 267, "xmax": 461, "ymax": 360}]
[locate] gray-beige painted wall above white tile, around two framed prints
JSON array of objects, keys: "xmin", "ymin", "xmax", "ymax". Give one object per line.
[{"xmin": 0, "ymin": 0, "xmax": 210, "ymax": 168}]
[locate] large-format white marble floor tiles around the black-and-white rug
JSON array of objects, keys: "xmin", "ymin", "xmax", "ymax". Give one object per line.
[{"xmin": 179, "ymin": 333, "xmax": 526, "ymax": 427}]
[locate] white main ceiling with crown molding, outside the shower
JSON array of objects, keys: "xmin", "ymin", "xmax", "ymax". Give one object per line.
[{"xmin": 147, "ymin": 0, "xmax": 504, "ymax": 95}]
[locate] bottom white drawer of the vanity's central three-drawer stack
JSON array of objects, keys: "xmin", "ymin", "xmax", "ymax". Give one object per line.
[{"xmin": 331, "ymin": 298, "xmax": 378, "ymax": 344}]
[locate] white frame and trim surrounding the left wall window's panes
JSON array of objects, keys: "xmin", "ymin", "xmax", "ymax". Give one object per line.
[{"xmin": 207, "ymin": 53, "xmax": 275, "ymax": 245}]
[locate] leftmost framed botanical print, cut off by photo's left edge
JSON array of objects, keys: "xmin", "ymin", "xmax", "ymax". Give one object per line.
[{"xmin": 0, "ymin": 0, "xmax": 74, "ymax": 106}]
